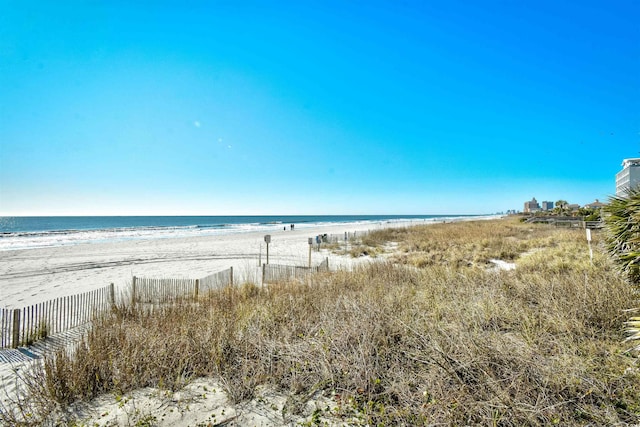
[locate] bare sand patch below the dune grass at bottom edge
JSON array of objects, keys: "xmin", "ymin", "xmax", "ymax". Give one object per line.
[{"xmin": 66, "ymin": 378, "xmax": 344, "ymax": 427}]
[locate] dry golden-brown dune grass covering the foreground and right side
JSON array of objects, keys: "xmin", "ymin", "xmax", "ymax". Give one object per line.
[{"xmin": 0, "ymin": 220, "xmax": 640, "ymax": 426}]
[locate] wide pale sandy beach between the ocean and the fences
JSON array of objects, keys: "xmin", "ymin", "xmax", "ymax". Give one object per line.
[{"xmin": 0, "ymin": 222, "xmax": 418, "ymax": 308}]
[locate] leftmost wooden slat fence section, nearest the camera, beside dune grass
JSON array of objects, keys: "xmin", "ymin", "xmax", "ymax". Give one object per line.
[{"xmin": 0, "ymin": 284, "xmax": 115, "ymax": 348}]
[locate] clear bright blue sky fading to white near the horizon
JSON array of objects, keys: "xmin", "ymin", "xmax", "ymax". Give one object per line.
[{"xmin": 0, "ymin": 0, "xmax": 640, "ymax": 215}]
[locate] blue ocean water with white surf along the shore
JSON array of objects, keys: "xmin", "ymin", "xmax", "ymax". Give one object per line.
[{"xmin": 0, "ymin": 215, "xmax": 470, "ymax": 251}]
